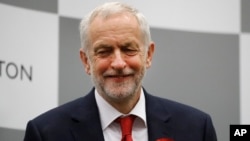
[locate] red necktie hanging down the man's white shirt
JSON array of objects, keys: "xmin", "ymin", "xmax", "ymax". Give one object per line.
[{"xmin": 117, "ymin": 115, "xmax": 135, "ymax": 141}]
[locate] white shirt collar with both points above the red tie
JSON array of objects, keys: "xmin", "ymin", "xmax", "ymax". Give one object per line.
[{"xmin": 95, "ymin": 89, "xmax": 147, "ymax": 130}]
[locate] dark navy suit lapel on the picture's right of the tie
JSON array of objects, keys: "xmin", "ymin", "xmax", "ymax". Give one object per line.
[{"xmin": 144, "ymin": 91, "xmax": 173, "ymax": 141}]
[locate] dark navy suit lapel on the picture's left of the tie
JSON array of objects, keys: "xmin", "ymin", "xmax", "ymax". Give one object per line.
[{"xmin": 71, "ymin": 89, "xmax": 104, "ymax": 141}]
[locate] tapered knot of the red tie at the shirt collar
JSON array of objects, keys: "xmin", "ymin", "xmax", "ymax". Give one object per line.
[{"xmin": 117, "ymin": 115, "xmax": 135, "ymax": 137}]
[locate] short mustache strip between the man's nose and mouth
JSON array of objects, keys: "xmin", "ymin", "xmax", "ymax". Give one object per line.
[{"xmin": 103, "ymin": 69, "xmax": 135, "ymax": 77}]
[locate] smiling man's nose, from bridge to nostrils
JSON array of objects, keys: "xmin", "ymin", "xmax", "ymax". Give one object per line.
[{"xmin": 111, "ymin": 50, "xmax": 126, "ymax": 70}]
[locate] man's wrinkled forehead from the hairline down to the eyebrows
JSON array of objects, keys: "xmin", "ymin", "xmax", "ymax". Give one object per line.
[{"xmin": 89, "ymin": 13, "xmax": 143, "ymax": 48}]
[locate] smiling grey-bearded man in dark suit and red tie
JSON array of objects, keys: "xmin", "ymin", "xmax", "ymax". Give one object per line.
[{"xmin": 24, "ymin": 2, "xmax": 216, "ymax": 141}]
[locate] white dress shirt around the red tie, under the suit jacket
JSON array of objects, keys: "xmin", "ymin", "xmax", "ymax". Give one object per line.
[{"xmin": 95, "ymin": 89, "xmax": 148, "ymax": 141}]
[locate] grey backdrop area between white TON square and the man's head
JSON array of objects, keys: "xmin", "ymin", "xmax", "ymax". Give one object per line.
[{"xmin": 59, "ymin": 17, "xmax": 92, "ymax": 104}]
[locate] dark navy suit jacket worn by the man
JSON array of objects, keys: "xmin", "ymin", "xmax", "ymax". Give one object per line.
[{"xmin": 24, "ymin": 89, "xmax": 217, "ymax": 141}]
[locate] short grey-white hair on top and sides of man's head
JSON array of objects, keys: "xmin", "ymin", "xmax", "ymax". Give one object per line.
[{"xmin": 80, "ymin": 2, "xmax": 151, "ymax": 52}]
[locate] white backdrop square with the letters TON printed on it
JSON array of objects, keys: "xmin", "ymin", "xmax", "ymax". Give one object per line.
[{"xmin": 0, "ymin": 4, "xmax": 58, "ymax": 129}]
